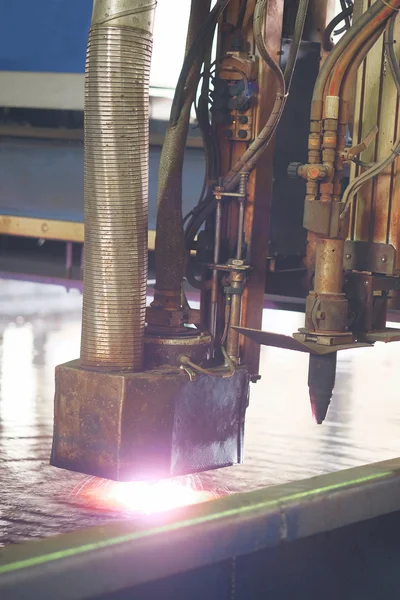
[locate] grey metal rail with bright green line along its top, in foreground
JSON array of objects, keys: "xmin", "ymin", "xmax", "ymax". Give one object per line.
[{"xmin": 0, "ymin": 458, "xmax": 400, "ymax": 600}]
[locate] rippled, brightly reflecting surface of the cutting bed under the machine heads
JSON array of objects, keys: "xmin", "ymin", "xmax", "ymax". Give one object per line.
[{"xmin": 0, "ymin": 281, "xmax": 400, "ymax": 546}]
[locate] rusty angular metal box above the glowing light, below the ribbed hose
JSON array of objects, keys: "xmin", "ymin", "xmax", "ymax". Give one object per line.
[{"xmin": 51, "ymin": 361, "xmax": 249, "ymax": 481}]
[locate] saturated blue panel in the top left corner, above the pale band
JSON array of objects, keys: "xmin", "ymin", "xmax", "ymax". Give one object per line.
[{"xmin": 0, "ymin": 0, "xmax": 93, "ymax": 73}]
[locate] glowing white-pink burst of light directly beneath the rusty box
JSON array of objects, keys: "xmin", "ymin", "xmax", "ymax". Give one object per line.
[{"xmin": 74, "ymin": 476, "xmax": 217, "ymax": 514}]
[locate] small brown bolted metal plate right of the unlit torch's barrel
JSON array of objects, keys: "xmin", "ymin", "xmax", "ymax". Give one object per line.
[{"xmin": 343, "ymin": 241, "xmax": 397, "ymax": 275}]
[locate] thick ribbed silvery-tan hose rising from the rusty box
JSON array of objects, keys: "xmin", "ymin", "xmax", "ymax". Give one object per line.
[{"xmin": 81, "ymin": 0, "xmax": 156, "ymax": 371}]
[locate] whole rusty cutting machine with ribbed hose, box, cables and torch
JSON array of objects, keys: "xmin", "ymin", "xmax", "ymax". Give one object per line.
[{"xmin": 51, "ymin": 0, "xmax": 400, "ymax": 481}]
